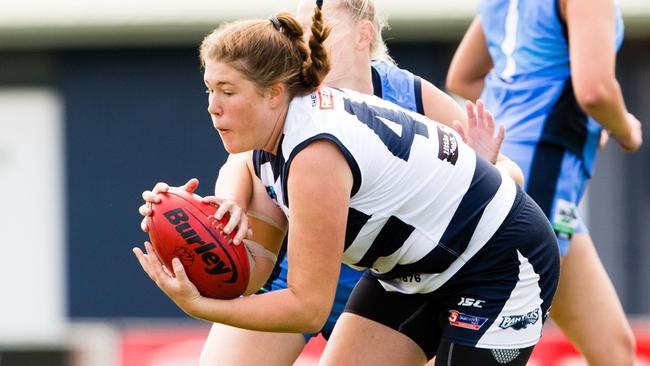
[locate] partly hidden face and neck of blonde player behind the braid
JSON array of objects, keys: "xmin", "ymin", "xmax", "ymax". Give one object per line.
[{"xmin": 296, "ymin": 0, "xmax": 359, "ymax": 86}]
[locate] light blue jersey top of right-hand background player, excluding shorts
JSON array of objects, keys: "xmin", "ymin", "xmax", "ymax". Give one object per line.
[{"xmin": 479, "ymin": 0, "xmax": 623, "ymax": 173}]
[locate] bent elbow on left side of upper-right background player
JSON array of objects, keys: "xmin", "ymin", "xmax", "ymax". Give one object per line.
[{"xmin": 446, "ymin": 16, "xmax": 493, "ymax": 101}]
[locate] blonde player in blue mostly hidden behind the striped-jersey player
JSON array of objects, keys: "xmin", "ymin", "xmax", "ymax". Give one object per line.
[{"xmin": 201, "ymin": 0, "xmax": 521, "ymax": 365}]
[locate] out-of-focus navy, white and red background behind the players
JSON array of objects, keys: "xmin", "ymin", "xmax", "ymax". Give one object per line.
[{"xmin": 0, "ymin": 0, "xmax": 650, "ymax": 366}]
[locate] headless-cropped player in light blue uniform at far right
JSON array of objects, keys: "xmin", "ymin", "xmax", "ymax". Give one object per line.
[{"xmin": 447, "ymin": 0, "xmax": 642, "ymax": 365}]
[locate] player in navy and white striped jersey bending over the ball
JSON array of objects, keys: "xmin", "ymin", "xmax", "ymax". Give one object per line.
[{"xmin": 134, "ymin": 4, "xmax": 559, "ymax": 365}]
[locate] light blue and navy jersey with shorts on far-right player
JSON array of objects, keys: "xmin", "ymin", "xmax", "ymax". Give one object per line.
[{"xmin": 479, "ymin": 0, "xmax": 623, "ymax": 254}]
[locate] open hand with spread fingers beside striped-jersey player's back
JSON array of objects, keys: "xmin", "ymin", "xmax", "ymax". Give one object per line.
[{"xmin": 454, "ymin": 99, "xmax": 505, "ymax": 164}]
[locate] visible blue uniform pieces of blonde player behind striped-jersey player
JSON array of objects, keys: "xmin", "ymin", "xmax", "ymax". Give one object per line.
[{"xmin": 265, "ymin": 61, "xmax": 423, "ymax": 340}]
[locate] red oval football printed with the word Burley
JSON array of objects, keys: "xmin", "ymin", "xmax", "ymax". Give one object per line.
[{"xmin": 148, "ymin": 190, "xmax": 250, "ymax": 299}]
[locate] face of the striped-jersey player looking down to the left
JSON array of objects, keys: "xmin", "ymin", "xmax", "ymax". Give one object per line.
[{"xmin": 203, "ymin": 60, "xmax": 273, "ymax": 153}]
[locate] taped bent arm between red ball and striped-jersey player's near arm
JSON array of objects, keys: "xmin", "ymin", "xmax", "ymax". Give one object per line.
[{"xmin": 214, "ymin": 152, "xmax": 286, "ymax": 295}]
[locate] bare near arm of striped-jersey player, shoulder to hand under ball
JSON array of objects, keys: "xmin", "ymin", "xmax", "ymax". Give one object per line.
[{"xmin": 156, "ymin": 141, "xmax": 353, "ymax": 333}]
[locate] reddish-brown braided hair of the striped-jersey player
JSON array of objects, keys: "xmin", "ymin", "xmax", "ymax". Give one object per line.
[{"xmin": 200, "ymin": 1, "xmax": 330, "ymax": 96}]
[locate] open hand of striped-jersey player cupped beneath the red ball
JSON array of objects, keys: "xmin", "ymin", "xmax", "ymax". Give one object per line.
[{"xmin": 133, "ymin": 242, "xmax": 201, "ymax": 314}]
